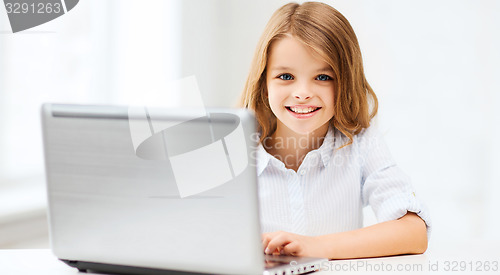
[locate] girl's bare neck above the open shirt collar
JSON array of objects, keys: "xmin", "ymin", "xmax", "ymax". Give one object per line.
[{"xmin": 263, "ymin": 123, "xmax": 329, "ymax": 171}]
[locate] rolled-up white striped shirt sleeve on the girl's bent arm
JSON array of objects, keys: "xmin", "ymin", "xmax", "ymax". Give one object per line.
[{"xmin": 358, "ymin": 126, "xmax": 431, "ymax": 236}]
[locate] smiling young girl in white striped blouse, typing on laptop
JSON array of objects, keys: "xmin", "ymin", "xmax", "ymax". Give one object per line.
[{"xmin": 238, "ymin": 2, "xmax": 429, "ymax": 259}]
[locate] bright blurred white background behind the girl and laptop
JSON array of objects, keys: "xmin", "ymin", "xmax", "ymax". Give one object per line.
[{"xmin": 0, "ymin": 0, "xmax": 500, "ymax": 249}]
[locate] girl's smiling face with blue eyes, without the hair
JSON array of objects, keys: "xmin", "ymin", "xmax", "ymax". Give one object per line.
[{"xmin": 266, "ymin": 36, "xmax": 335, "ymax": 135}]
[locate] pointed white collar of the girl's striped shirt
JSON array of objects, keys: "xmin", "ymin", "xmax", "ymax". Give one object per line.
[{"xmin": 257, "ymin": 126, "xmax": 335, "ymax": 176}]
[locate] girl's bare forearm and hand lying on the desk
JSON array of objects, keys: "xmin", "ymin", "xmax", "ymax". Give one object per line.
[{"xmin": 262, "ymin": 212, "xmax": 427, "ymax": 259}]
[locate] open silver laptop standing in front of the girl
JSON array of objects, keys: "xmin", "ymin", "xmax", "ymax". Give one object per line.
[{"xmin": 42, "ymin": 104, "xmax": 326, "ymax": 275}]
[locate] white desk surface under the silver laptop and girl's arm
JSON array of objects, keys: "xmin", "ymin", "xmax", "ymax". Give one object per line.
[{"xmin": 0, "ymin": 242, "xmax": 500, "ymax": 275}]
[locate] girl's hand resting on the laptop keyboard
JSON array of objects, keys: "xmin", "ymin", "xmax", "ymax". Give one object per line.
[{"xmin": 262, "ymin": 231, "xmax": 322, "ymax": 257}]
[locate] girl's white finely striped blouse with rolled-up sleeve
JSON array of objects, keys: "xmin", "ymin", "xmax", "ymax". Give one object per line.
[{"xmin": 257, "ymin": 126, "xmax": 430, "ymax": 236}]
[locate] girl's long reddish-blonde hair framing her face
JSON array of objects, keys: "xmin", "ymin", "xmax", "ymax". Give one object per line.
[{"xmin": 240, "ymin": 2, "xmax": 378, "ymax": 145}]
